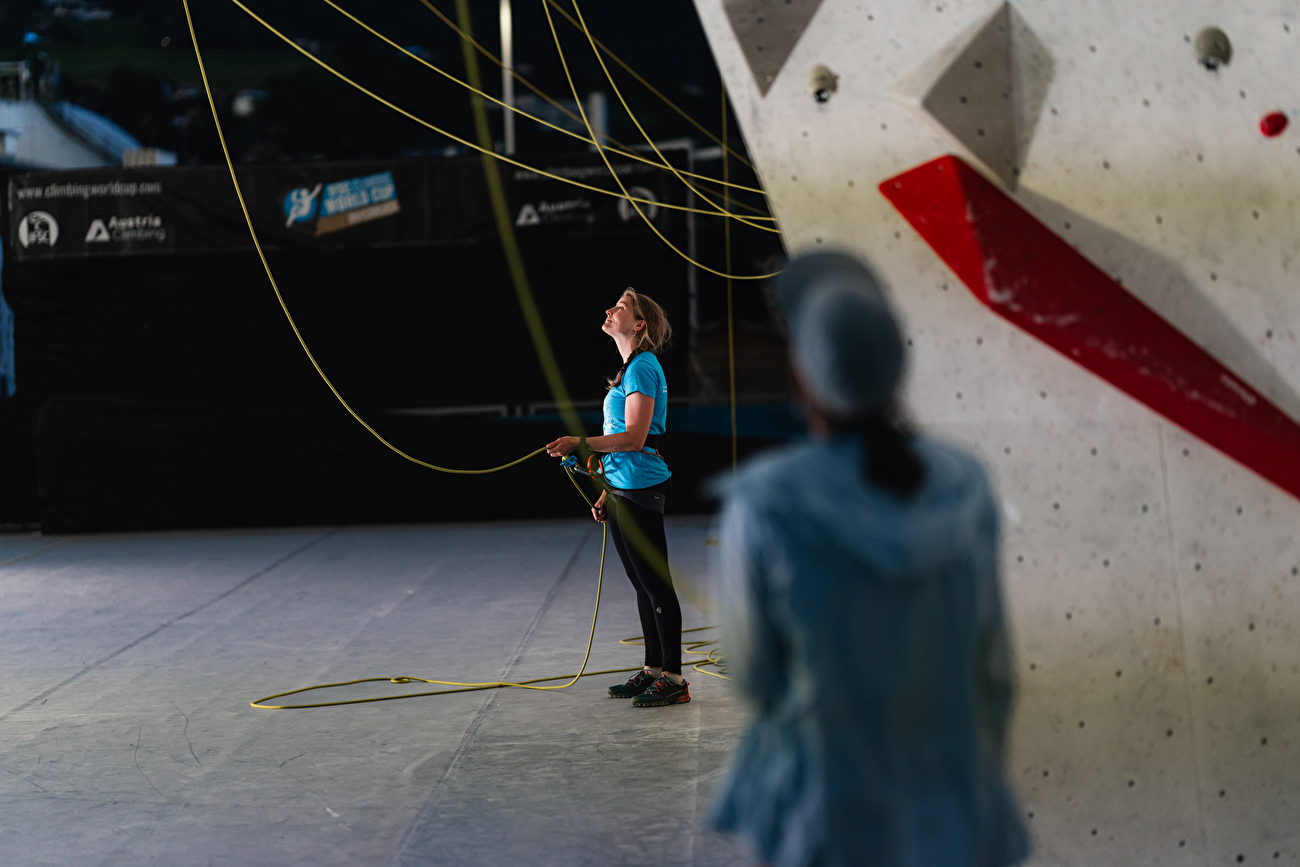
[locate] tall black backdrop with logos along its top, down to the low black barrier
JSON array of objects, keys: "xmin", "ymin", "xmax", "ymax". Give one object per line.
[{"xmin": 4, "ymin": 155, "xmax": 688, "ymax": 411}]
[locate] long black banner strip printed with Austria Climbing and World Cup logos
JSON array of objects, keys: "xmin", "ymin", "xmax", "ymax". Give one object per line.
[{"xmin": 8, "ymin": 152, "xmax": 681, "ymax": 261}]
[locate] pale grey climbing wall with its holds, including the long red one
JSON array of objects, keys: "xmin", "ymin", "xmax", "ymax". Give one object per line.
[{"xmin": 697, "ymin": 0, "xmax": 1300, "ymax": 866}]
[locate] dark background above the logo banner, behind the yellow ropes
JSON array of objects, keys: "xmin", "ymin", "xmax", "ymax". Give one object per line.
[{"xmin": 0, "ymin": 0, "xmax": 753, "ymax": 168}]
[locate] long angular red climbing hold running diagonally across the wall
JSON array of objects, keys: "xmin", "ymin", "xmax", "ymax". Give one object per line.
[{"xmin": 880, "ymin": 156, "xmax": 1300, "ymax": 498}]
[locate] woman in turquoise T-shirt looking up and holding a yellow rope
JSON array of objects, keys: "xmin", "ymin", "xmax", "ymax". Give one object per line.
[{"xmin": 546, "ymin": 289, "xmax": 690, "ymax": 707}]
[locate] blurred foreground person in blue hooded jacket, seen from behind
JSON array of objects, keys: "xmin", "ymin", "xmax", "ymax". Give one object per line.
[{"xmin": 714, "ymin": 253, "xmax": 1028, "ymax": 867}]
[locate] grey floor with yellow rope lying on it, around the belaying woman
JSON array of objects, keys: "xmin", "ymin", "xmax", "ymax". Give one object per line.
[{"xmin": 0, "ymin": 519, "xmax": 750, "ymax": 866}]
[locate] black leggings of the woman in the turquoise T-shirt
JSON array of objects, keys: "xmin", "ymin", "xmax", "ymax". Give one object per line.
[{"xmin": 605, "ymin": 494, "xmax": 681, "ymax": 675}]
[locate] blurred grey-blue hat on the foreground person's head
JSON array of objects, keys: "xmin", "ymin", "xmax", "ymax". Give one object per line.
[{"xmin": 777, "ymin": 253, "xmax": 904, "ymax": 419}]
